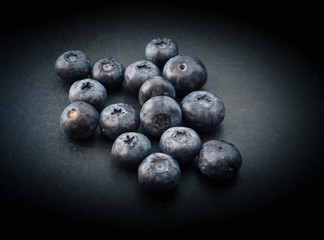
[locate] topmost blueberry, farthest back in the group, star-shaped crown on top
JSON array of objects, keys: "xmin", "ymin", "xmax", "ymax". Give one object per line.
[{"xmin": 145, "ymin": 37, "xmax": 178, "ymax": 70}]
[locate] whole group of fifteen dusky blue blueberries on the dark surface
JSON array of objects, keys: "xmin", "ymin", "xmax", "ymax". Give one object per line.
[{"xmin": 55, "ymin": 37, "xmax": 242, "ymax": 191}]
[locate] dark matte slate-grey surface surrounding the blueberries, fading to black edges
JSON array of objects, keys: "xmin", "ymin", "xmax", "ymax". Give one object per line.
[{"xmin": 0, "ymin": 2, "xmax": 323, "ymax": 236}]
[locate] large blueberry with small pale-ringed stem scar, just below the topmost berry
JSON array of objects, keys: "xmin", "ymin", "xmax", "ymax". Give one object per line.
[{"xmin": 163, "ymin": 55, "xmax": 207, "ymax": 96}]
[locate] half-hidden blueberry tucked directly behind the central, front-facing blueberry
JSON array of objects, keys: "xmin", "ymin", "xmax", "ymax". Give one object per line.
[{"xmin": 138, "ymin": 76, "xmax": 176, "ymax": 105}]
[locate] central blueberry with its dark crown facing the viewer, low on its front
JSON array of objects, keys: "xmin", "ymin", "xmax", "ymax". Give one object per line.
[{"xmin": 140, "ymin": 96, "xmax": 182, "ymax": 137}]
